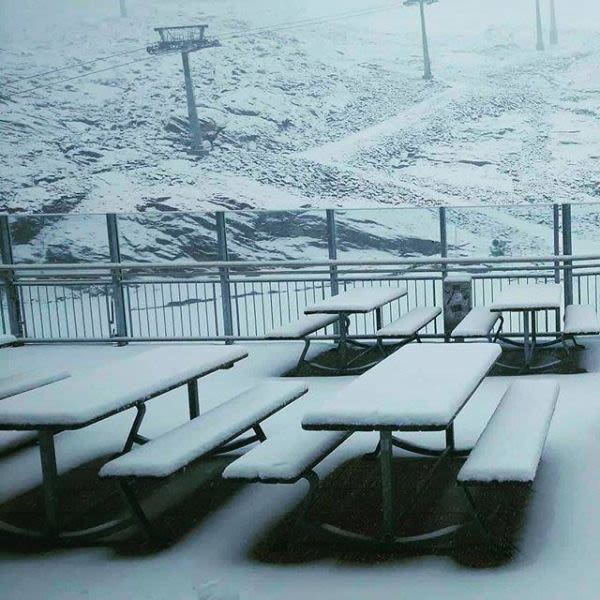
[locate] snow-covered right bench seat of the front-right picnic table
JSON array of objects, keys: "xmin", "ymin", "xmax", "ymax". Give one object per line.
[{"xmin": 458, "ymin": 379, "xmax": 559, "ymax": 483}]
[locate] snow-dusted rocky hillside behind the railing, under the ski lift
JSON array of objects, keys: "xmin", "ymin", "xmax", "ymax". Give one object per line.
[{"xmin": 0, "ymin": 0, "xmax": 600, "ymax": 257}]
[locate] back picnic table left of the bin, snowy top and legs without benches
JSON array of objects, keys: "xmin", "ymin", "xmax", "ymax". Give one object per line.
[{"xmin": 304, "ymin": 284, "xmax": 408, "ymax": 371}]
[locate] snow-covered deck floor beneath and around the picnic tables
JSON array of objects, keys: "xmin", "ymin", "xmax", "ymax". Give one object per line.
[{"xmin": 0, "ymin": 339, "xmax": 600, "ymax": 600}]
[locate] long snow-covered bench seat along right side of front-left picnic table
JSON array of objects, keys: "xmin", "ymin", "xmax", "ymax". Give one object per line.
[{"xmin": 100, "ymin": 379, "xmax": 308, "ymax": 477}]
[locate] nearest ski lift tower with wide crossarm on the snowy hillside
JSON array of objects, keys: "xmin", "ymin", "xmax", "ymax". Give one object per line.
[{"xmin": 146, "ymin": 25, "xmax": 220, "ymax": 153}]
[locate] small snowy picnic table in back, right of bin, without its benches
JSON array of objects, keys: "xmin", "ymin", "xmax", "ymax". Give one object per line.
[{"xmin": 490, "ymin": 283, "xmax": 562, "ymax": 371}]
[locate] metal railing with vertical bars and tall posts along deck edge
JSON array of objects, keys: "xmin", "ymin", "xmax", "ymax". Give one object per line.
[{"xmin": 0, "ymin": 205, "xmax": 600, "ymax": 342}]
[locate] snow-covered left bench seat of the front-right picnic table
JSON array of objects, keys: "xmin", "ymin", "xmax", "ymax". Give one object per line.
[{"xmin": 223, "ymin": 426, "xmax": 350, "ymax": 483}]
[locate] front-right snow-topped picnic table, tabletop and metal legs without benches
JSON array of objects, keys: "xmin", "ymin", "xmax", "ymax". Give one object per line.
[{"xmin": 302, "ymin": 343, "xmax": 501, "ymax": 545}]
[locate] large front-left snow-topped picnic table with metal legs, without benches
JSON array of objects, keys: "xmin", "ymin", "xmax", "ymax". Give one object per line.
[{"xmin": 0, "ymin": 345, "xmax": 248, "ymax": 539}]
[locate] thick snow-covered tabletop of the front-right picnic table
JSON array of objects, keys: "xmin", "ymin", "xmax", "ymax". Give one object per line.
[{"xmin": 302, "ymin": 343, "xmax": 501, "ymax": 430}]
